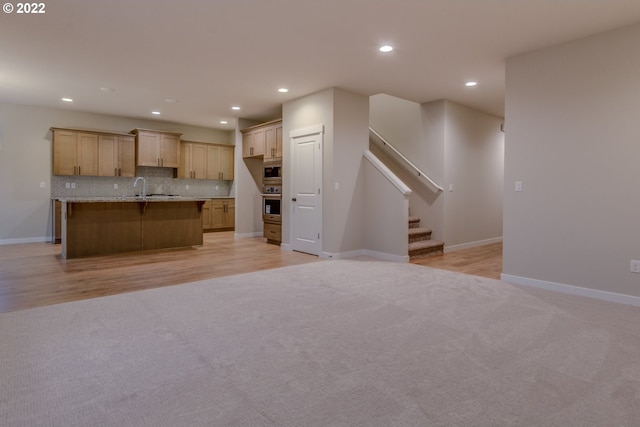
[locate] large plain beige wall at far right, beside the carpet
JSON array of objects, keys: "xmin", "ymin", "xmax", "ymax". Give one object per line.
[{"xmin": 503, "ymin": 25, "xmax": 640, "ymax": 296}]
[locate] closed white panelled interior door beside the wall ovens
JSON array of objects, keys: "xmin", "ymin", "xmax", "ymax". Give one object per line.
[{"xmin": 290, "ymin": 125, "xmax": 323, "ymax": 255}]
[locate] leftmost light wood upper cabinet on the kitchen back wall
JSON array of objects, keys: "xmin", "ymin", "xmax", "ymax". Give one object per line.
[{"xmin": 52, "ymin": 128, "xmax": 98, "ymax": 176}]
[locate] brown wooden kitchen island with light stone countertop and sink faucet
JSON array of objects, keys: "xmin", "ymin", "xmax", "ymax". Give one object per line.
[{"xmin": 58, "ymin": 196, "xmax": 205, "ymax": 258}]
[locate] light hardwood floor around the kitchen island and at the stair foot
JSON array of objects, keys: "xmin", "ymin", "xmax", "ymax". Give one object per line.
[{"xmin": 0, "ymin": 231, "xmax": 502, "ymax": 312}]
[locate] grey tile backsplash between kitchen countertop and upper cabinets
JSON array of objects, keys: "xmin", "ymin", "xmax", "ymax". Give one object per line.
[{"xmin": 51, "ymin": 167, "xmax": 233, "ymax": 198}]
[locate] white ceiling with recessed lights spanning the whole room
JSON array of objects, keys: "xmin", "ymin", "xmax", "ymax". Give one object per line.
[{"xmin": 0, "ymin": 0, "xmax": 640, "ymax": 129}]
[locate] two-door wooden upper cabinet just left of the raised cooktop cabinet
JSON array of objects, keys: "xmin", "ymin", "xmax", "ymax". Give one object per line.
[{"xmin": 98, "ymin": 134, "xmax": 136, "ymax": 177}]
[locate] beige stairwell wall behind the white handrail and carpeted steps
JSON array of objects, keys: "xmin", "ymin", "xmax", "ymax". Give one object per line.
[{"xmin": 370, "ymin": 95, "xmax": 504, "ymax": 250}]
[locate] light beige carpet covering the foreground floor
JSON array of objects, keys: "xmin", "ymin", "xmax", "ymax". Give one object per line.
[{"xmin": 0, "ymin": 261, "xmax": 640, "ymax": 427}]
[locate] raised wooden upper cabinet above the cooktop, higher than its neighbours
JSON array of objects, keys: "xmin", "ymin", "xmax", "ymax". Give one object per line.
[{"xmin": 132, "ymin": 129, "xmax": 181, "ymax": 168}]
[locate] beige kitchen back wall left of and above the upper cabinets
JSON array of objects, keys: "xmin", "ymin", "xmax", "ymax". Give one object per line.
[{"xmin": 0, "ymin": 104, "xmax": 232, "ymax": 243}]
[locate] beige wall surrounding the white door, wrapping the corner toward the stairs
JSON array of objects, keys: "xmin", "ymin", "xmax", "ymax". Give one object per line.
[{"xmin": 282, "ymin": 88, "xmax": 369, "ymax": 257}]
